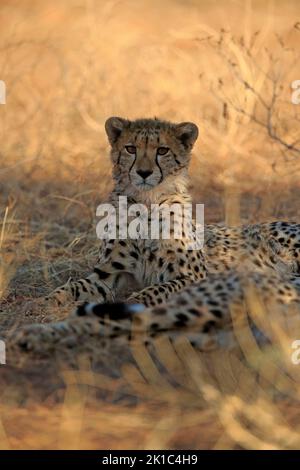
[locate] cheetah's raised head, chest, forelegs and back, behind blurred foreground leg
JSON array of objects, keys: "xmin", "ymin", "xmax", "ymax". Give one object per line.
[{"xmin": 42, "ymin": 117, "xmax": 300, "ymax": 306}]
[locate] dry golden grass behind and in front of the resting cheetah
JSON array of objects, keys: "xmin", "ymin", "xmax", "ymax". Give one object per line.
[{"xmin": 0, "ymin": 0, "xmax": 300, "ymax": 448}]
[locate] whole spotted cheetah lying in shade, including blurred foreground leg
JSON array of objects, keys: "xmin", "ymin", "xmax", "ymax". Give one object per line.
[{"xmin": 8, "ymin": 117, "xmax": 300, "ymax": 351}]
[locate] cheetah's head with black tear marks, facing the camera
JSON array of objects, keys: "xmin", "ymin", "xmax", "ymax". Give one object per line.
[{"xmin": 105, "ymin": 117, "xmax": 198, "ymax": 191}]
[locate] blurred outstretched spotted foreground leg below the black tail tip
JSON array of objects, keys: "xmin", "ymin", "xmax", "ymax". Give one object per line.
[{"xmin": 11, "ymin": 304, "xmax": 237, "ymax": 355}]
